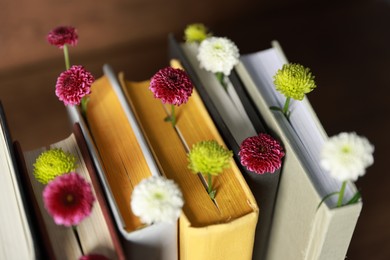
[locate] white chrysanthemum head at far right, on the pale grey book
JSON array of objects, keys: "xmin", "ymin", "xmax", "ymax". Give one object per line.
[{"xmin": 320, "ymin": 132, "xmax": 374, "ymax": 181}]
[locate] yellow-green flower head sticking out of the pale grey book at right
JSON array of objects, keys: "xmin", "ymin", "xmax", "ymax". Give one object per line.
[{"xmin": 274, "ymin": 63, "xmax": 316, "ymax": 100}]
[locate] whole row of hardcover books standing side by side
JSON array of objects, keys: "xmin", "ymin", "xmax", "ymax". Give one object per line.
[{"xmin": 0, "ymin": 29, "xmax": 362, "ymax": 260}]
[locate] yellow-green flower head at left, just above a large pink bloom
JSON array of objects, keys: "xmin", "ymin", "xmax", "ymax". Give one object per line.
[{"xmin": 33, "ymin": 148, "xmax": 77, "ymax": 185}]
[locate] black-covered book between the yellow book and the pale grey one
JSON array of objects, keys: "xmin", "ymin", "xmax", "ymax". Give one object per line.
[{"xmin": 168, "ymin": 34, "xmax": 280, "ymax": 259}]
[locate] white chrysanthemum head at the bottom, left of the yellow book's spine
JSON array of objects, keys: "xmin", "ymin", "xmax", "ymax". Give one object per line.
[{"xmin": 131, "ymin": 176, "xmax": 184, "ymax": 224}]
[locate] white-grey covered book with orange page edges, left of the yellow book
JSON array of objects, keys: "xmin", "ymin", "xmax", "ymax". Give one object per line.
[{"xmin": 84, "ymin": 69, "xmax": 178, "ymax": 260}]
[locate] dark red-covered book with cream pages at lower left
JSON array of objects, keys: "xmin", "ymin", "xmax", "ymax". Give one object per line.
[{"xmin": 16, "ymin": 124, "xmax": 125, "ymax": 259}]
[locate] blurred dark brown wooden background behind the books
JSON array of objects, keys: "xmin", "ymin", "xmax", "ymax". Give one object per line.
[{"xmin": 0, "ymin": 0, "xmax": 390, "ymax": 259}]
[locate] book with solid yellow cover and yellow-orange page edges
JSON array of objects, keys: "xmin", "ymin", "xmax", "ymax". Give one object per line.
[{"xmin": 116, "ymin": 61, "xmax": 259, "ymax": 260}]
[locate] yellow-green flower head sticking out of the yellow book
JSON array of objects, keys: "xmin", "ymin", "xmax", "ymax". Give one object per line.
[{"xmin": 188, "ymin": 140, "xmax": 233, "ymax": 175}]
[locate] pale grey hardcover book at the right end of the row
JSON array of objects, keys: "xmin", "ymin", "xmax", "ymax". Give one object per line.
[{"xmin": 235, "ymin": 41, "xmax": 362, "ymax": 260}]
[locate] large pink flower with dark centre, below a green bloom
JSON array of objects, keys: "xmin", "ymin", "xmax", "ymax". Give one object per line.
[{"xmin": 43, "ymin": 172, "xmax": 95, "ymax": 226}]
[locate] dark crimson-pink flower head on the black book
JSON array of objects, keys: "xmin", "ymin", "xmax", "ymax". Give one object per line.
[{"xmin": 238, "ymin": 133, "xmax": 284, "ymax": 174}]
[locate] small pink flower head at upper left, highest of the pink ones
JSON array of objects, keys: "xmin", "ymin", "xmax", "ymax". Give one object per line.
[{"xmin": 46, "ymin": 26, "xmax": 78, "ymax": 49}]
